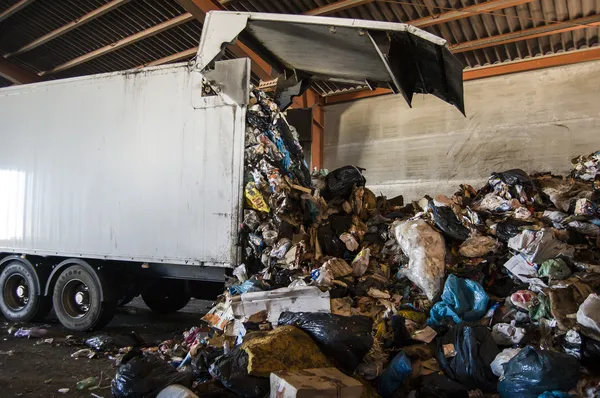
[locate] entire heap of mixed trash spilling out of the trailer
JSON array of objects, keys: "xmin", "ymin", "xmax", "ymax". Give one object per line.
[{"xmin": 113, "ymin": 90, "xmax": 600, "ymax": 398}]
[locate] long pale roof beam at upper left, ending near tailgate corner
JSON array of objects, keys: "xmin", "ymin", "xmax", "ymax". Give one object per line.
[{"xmin": 39, "ymin": 13, "xmax": 194, "ymax": 76}]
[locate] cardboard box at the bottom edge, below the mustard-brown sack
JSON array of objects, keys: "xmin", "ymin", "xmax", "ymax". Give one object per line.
[{"xmin": 271, "ymin": 368, "xmax": 363, "ymax": 398}]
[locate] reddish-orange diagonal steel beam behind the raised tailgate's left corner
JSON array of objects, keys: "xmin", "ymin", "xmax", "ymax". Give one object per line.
[{"xmin": 177, "ymin": 0, "xmax": 273, "ymax": 80}]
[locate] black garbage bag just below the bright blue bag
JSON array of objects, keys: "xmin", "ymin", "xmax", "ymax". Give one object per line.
[{"xmin": 435, "ymin": 322, "xmax": 500, "ymax": 392}]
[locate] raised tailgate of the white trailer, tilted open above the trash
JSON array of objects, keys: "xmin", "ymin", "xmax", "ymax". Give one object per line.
[{"xmin": 196, "ymin": 11, "xmax": 465, "ymax": 114}]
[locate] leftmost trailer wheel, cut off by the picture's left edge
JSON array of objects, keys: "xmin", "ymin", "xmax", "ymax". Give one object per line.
[{"xmin": 0, "ymin": 261, "xmax": 52, "ymax": 322}]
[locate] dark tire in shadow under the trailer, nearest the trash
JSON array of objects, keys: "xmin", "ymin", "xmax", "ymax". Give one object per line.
[{"xmin": 142, "ymin": 280, "xmax": 192, "ymax": 314}]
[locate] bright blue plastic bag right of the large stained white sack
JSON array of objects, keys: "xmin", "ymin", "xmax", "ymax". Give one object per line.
[{"xmin": 427, "ymin": 274, "xmax": 489, "ymax": 326}]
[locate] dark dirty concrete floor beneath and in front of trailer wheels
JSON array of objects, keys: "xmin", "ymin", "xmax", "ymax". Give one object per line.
[{"xmin": 0, "ymin": 299, "xmax": 210, "ymax": 398}]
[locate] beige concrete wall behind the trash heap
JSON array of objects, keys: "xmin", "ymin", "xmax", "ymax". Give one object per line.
[{"xmin": 324, "ymin": 62, "xmax": 600, "ymax": 200}]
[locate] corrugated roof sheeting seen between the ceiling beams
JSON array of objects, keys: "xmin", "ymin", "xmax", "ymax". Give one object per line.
[{"xmin": 0, "ymin": 0, "xmax": 600, "ymax": 95}]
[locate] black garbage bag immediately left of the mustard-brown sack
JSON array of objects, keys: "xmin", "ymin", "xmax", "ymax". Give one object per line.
[{"xmin": 210, "ymin": 346, "xmax": 270, "ymax": 398}]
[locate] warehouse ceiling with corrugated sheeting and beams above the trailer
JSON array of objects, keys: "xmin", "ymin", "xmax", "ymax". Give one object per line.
[{"xmin": 0, "ymin": 0, "xmax": 600, "ymax": 96}]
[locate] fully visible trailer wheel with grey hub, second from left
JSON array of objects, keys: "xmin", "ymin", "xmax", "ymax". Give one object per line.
[{"xmin": 52, "ymin": 264, "xmax": 117, "ymax": 332}]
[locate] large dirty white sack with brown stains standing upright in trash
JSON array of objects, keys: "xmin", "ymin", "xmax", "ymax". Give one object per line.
[{"xmin": 392, "ymin": 220, "xmax": 446, "ymax": 301}]
